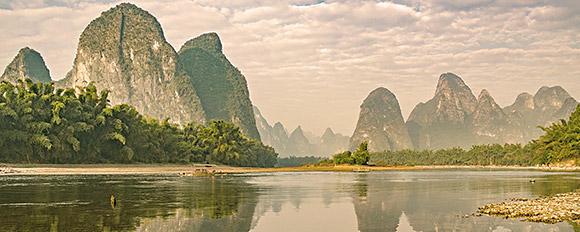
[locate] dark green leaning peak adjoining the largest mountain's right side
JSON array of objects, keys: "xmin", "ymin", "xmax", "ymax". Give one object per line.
[{"xmin": 178, "ymin": 33, "xmax": 260, "ymax": 140}]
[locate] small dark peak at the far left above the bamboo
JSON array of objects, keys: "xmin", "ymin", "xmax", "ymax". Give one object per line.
[{"xmin": 0, "ymin": 47, "xmax": 52, "ymax": 83}]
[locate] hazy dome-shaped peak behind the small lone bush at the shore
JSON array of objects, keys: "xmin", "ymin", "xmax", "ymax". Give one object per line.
[{"xmin": 350, "ymin": 88, "xmax": 413, "ymax": 151}]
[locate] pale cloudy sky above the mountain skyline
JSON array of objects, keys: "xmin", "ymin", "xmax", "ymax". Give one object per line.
[{"xmin": 0, "ymin": 0, "xmax": 580, "ymax": 136}]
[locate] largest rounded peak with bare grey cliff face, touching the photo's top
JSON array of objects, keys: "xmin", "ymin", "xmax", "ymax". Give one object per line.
[{"xmin": 59, "ymin": 3, "xmax": 206, "ymax": 123}]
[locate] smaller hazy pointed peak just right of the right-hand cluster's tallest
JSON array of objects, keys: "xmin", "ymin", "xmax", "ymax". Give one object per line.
[{"xmin": 469, "ymin": 89, "xmax": 525, "ymax": 144}]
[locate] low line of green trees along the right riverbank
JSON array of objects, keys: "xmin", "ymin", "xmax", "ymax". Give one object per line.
[{"xmin": 372, "ymin": 102, "xmax": 580, "ymax": 166}]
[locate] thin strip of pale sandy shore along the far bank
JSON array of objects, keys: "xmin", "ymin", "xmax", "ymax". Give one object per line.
[{"xmin": 0, "ymin": 164, "xmax": 580, "ymax": 175}]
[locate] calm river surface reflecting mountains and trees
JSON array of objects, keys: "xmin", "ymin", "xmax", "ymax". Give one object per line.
[{"xmin": 0, "ymin": 169, "xmax": 580, "ymax": 231}]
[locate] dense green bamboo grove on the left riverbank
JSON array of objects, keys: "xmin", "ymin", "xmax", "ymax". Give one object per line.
[{"xmin": 0, "ymin": 79, "xmax": 277, "ymax": 167}]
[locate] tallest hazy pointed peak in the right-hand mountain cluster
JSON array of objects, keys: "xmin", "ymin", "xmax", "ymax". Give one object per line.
[{"xmin": 407, "ymin": 73, "xmax": 477, "ymax": 149}]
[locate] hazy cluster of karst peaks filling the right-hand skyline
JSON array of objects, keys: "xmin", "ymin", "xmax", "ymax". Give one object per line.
[{"xmin": 350, "ymin": 73, "xmax": 578, "ymax": 151}]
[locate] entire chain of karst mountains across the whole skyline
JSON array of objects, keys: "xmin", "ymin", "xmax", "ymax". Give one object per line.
[{"xmin": 2, "ymin": 3, "xmax": 578, "ymax": 156}]
